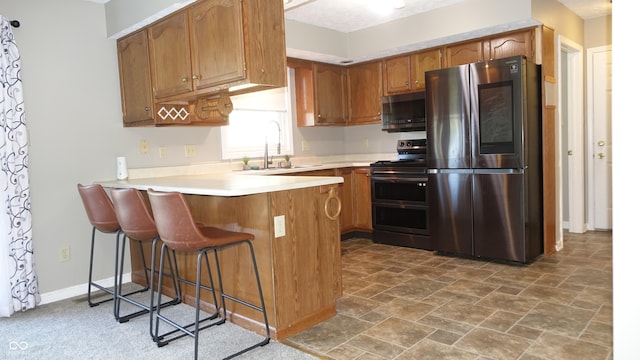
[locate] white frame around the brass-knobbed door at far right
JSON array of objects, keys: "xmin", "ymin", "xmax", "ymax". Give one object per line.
[{"xmin": 586, "ymin": 45, "xmax": 612, "ymax": 230}]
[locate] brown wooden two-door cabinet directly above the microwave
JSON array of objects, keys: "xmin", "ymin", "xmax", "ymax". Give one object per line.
[{"xmin": 382, "ymin": 49, "xmax": 442, "ymax": 95}]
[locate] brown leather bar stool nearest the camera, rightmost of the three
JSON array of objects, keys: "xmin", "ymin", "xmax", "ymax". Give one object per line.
[{"xmin": 147, "ymin": 189, "xmax": 270, "ymax": 359}]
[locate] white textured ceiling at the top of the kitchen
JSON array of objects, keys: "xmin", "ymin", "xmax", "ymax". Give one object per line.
[{"xmin": 285, "ymin": 0, "xmax": 611, "ymax": 33}]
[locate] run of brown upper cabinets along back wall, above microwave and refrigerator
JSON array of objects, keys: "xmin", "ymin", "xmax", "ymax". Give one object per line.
[{"xmin": 288, "ymin": 28, "xmax": 535, "ymax": 126}]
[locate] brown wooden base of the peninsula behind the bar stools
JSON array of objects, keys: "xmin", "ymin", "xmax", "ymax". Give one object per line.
[{"xmin": 130, "ymin": 185, "xmax": 342, "ymax": 340}]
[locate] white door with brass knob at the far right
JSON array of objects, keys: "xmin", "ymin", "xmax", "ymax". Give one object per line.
[{"xmin": 588, "ymin": 46, "xmax": 612, "ymax": 229}]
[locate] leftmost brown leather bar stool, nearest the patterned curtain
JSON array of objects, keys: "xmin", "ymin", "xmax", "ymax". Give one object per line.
[{"xmin": 78, "ymin": 184, "xmax": 145, "ymax": 316}]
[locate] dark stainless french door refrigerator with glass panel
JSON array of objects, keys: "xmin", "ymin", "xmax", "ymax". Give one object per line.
[{"xmin": 425, "ymin": 56, "xmax": 543, "ymax": 263}]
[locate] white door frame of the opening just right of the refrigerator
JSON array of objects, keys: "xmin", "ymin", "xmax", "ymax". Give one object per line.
[{"xmin": 556, "ymin": 35, "xmax": 586, "ymax": 242}]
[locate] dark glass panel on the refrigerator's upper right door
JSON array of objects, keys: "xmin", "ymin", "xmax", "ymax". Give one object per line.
[{"xmin": 478, "ymin": 81, "xmax": 515, "ymax": 154}]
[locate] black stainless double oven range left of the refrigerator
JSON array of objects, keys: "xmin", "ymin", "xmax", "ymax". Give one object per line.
[{"xmin": 370, "ymin": 139, "xmax": 433, "ymax": 250}]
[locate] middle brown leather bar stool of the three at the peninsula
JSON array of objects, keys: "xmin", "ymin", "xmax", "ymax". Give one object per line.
[{"xmin": 111, "ymin": 189, "xmax": 181, "ymax": 336}]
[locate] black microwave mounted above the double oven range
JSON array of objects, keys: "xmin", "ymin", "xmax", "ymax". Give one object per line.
[{"xmin": 382, "ymin": 91, "xmax": 425, "ymax": 132}]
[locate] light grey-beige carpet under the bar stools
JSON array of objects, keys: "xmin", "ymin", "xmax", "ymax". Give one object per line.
[{"xmin": 0, "ymin": 286, "xmax": 317, "ymax": 360}]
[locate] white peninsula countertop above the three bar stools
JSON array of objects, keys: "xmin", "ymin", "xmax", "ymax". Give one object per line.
[{"xmin": 96, "ymin": 172, "xmax": 344, "ymax": 196}]
